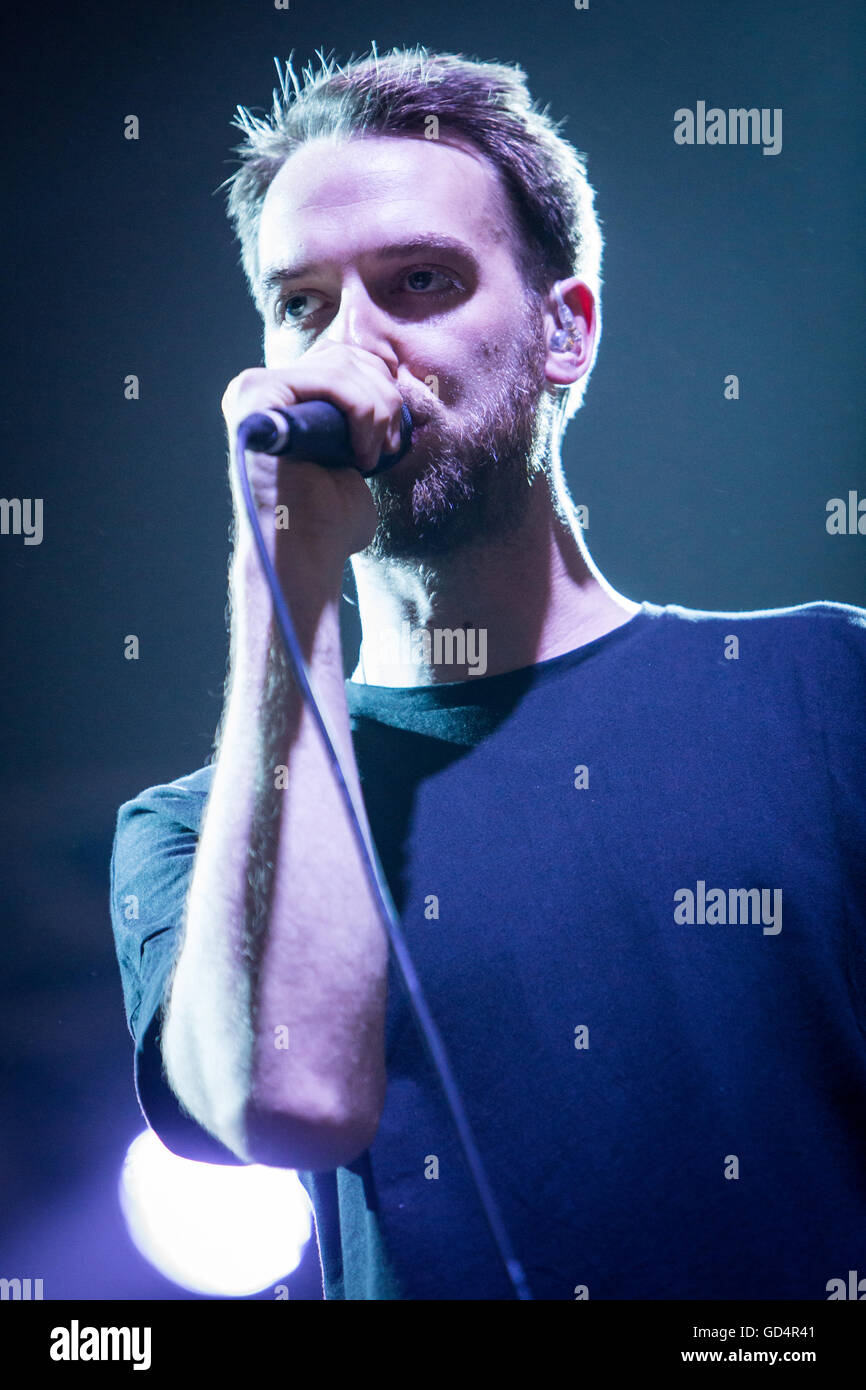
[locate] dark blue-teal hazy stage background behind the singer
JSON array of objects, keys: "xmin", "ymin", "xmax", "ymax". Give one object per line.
[{"xmin": 0, "ymin": 0, "xmax": 866, "ymax": 1300}]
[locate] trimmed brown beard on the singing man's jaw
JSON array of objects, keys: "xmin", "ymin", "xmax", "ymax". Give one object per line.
[{"xmin": 361, "ymin": 299, "xmax": 553, "ymax": 563}]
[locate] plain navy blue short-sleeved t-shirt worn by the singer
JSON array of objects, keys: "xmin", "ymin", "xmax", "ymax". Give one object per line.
[{"xmin": 111, "ymin": 603, "xmax": 866, "ymax": 1300}]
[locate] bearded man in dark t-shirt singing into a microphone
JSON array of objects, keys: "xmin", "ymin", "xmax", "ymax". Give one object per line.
[{"xmin": 113, "ymin": 50, "xmax": 866, "ymax": 1300}]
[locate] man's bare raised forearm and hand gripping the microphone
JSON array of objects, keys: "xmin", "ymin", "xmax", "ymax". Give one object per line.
[{"xmin": 163, "ymin": 348, "xmax": 400, "ymax": 1170}]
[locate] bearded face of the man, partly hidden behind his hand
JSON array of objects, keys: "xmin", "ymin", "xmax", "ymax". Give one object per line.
[{"xmin": 259, "ymin": 136, "xmax": 549, "ymax": 562}]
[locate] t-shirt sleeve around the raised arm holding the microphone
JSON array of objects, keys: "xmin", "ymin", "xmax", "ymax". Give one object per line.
[{"xmin": 110, "ymin": 787, "xmax": 243, "ymax": 1166}]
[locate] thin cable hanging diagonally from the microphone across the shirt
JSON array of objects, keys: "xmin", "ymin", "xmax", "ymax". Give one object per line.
[{"xmin": 234, "ymin": 407, "xmax": 532, "ymax": 1301}]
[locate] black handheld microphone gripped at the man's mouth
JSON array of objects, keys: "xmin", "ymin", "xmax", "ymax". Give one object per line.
[{"xmin": 238, "ymin": 400, "xmax": 413, "ymax": 478}]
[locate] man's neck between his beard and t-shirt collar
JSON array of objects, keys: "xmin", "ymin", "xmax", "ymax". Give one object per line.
[{"xmin": 352, "ymin": 477, "xmax": 639, "ymax": 687}]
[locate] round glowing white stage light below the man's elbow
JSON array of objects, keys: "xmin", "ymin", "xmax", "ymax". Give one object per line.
[{"xmin": 120, "ymin": 1130, "xmax": 311, "ymax": 1298}]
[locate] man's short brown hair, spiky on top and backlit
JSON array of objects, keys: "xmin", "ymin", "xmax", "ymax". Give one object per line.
[{"xmin": 222, "ymin": 44, "xmax": 603, "ymax": 425}]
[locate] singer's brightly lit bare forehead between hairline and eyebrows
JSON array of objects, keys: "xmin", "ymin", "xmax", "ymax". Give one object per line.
[{"xmin": 259, "ymin": 136, "xmax": 512, "ymax": 256}]
